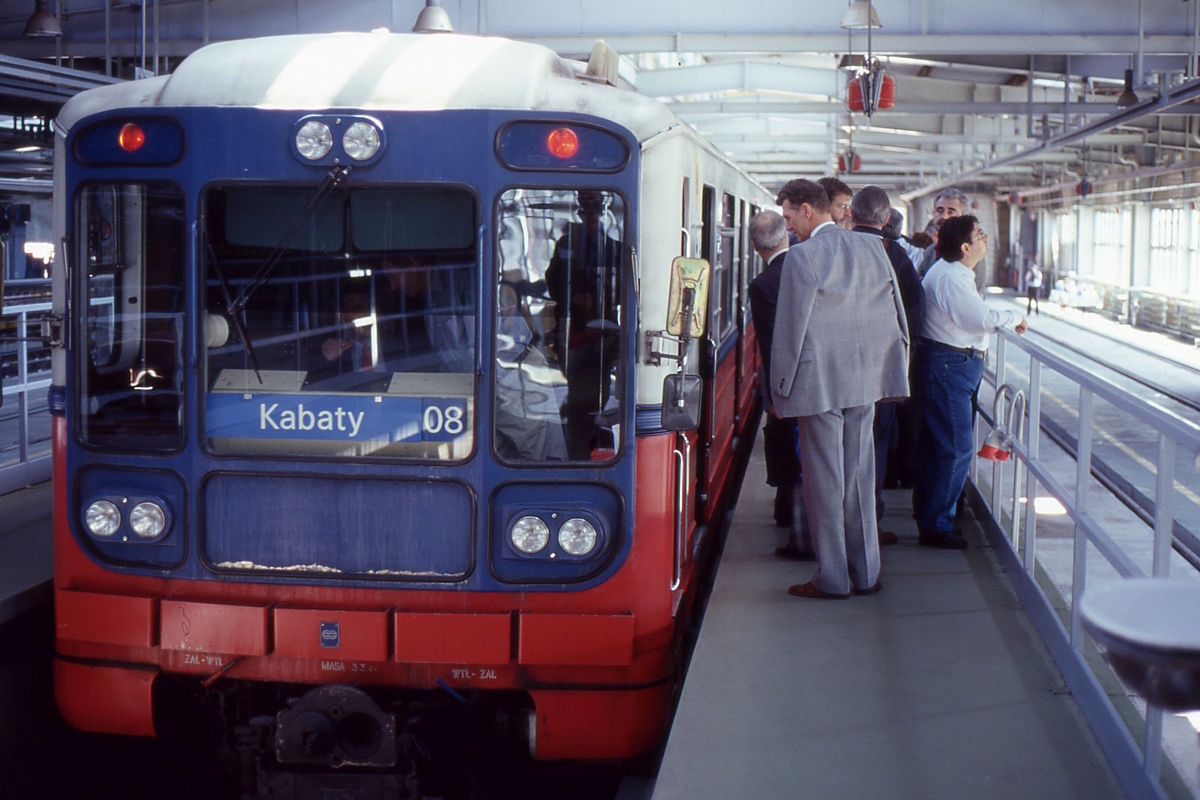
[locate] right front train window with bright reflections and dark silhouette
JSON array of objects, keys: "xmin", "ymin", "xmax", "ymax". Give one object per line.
[{"xmin": 492, "ymin": 188, "xmax": 626, "ymax": 463}]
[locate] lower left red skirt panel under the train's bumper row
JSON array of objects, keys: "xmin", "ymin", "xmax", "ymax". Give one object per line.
[{"xmin": 54, "ymin": 658, "xmax": 158, "ymax": 736}]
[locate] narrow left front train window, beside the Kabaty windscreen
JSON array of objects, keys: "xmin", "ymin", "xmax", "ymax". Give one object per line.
[{"xmin": 76, "ymin": 184, "xmax": 187, "ymax": 452}]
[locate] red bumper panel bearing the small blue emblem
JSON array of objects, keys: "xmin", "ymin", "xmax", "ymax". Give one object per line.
[{"xmin": 275, "ymin": 608, "xmax": 388, "ymax": 661}]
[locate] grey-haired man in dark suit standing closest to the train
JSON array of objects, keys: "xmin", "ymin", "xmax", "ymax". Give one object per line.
[{"xmin": 749, "ymin": 211, "xmax": 814, "ymax": 560}]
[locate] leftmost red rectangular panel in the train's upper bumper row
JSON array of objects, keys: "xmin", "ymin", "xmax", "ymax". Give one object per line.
[{"xmin": 54, "ymin": 591, "xmax": 158, "ymax": 648}]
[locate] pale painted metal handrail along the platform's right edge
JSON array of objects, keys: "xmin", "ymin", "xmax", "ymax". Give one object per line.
[{"xmin": 972, "ymin": 331, "xmax": 1200, "ymax": 798}]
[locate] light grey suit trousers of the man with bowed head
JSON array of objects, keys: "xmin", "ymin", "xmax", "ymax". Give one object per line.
[{"xmin": 797, "ymin": 404, "xmax": 880, "ymax": 595}]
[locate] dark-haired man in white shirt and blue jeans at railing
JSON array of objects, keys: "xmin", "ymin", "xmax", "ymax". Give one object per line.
[{"xmin": 912, "ymin": 215, "xmax": 1026, "ymax": 549}]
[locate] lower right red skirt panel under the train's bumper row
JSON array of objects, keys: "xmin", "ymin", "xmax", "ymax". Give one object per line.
[{"xmin": 529, "ymin": 684, "xmax": 671, "ymax": 759}]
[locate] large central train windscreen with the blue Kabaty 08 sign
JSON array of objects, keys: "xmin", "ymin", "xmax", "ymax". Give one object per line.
[{"xmin": 202, "ymin": 186, "xmax": 479, "ymax": 461}]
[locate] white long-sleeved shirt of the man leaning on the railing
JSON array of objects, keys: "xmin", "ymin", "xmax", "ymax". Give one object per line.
[{"xmin": 920, "ymin": 259, "xmax": 1021, "ymax": 350}]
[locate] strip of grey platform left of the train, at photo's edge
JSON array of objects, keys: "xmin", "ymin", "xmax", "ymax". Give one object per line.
[{"xmin": 0, "ymin": 481, "xmax": 53, "ymax": 625}]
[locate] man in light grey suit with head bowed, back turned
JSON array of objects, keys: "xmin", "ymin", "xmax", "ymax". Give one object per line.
[{"xmin": 770, "ymin": 180, "xmax": 908, "ymax": 599}]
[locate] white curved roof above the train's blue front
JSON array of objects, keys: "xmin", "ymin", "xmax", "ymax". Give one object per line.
[{"xmin": 58, "ymin": 32, "xmax": 683, "ymax": 142}]
